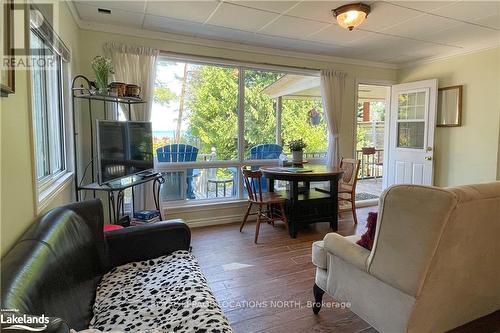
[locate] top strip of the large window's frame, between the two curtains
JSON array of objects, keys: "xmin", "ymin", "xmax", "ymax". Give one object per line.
[{"xmin": 160, "ymin": 50, "xmax": 321, "ymax": 76}]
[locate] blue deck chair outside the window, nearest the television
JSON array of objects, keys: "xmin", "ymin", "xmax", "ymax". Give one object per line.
[{"xmin": 156, "ymin": 144, "xmax": 199, "ymax": 199}]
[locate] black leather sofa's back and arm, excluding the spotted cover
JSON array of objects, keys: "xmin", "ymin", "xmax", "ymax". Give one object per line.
[{"xmin": 0, "ymin": 200, "xmax": 191, "ymax": 332}]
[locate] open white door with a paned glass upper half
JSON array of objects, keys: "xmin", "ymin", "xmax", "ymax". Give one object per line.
[{"xmin": 383, "ymin": 79, "xmax": 437, "ymax": 188}]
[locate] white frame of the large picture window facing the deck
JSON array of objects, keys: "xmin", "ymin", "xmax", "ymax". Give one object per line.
[{"xmin": 155, "ymin": 52, "xmax": 328, "ymax": 207}]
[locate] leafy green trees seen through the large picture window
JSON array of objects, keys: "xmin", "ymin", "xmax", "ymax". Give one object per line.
[{"xmin": 160, "ymin": 64, "xmax": 327, "ymax": 160}]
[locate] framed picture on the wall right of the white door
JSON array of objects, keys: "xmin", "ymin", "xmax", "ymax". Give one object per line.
[{"xmin": 436, "ymin": 85, "xmax": 463, "ymax": 127}]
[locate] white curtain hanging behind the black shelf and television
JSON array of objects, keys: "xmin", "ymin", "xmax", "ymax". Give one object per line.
[{"xmin": 104, "ymin": 42, "xmax": 160, "ymax": 210}]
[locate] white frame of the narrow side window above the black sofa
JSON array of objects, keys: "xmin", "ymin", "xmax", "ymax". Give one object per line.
[{"xmin": 26, "ymin": 26, "xmax": 73, "ymax": 213}]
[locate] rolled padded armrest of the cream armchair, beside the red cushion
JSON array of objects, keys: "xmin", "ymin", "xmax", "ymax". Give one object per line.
[{"xmin": 323, "ymin": 232, "xmax": 370, "ymax": 271}]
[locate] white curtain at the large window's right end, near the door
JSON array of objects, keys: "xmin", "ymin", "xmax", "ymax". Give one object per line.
[{"xmin": 321, "ymin": 69, "xmax": 347, "ymax": 167}]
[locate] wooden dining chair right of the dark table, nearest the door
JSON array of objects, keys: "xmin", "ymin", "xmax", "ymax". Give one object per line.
[{"xmin": 338, "ymin": 158, "xmax": 361, "ymax": 224}]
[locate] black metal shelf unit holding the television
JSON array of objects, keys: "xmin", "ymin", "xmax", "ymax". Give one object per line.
[{"xmin": 71, "ymin": 75, "xmax": 165, "ymax": 223}]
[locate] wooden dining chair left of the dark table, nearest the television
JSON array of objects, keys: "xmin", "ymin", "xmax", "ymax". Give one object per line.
[{"xmin": 240, "ymin": 166, "xmax": 288, "ymax": 243}]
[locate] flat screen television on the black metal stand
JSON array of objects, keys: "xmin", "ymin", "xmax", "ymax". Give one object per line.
[{"xmin": 96, "ymin": 120, "xmax": 154, "ymax": 185}]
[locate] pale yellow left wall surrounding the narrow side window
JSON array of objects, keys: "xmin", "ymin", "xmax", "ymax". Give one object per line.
[{"xmin": 0, "ymin": 1, "xmax": 79, "ymax": 256}]
